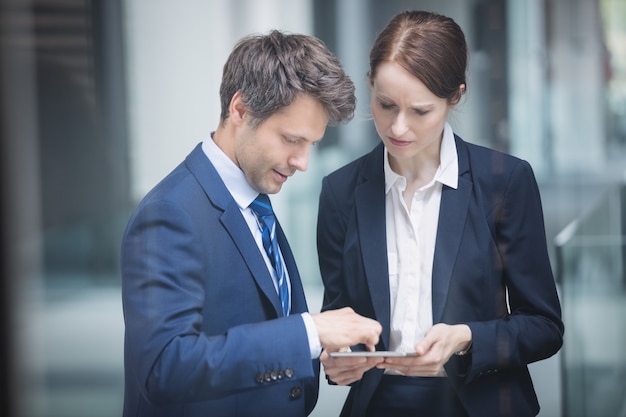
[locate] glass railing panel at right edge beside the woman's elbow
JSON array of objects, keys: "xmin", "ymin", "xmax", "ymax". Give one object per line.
[{"xmin": 555, "ymin": 185, "xmax": 626, "ymax": 417}]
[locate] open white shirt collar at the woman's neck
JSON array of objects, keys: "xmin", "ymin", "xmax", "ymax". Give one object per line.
[{"xmin": 384, "ymin": 122, "xmax": 459, "ymax": 193}]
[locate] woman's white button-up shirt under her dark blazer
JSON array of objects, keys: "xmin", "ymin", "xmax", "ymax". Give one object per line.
[{"xmin": 384, "ymin": 123, "xmax": 459, "ymax": 360}]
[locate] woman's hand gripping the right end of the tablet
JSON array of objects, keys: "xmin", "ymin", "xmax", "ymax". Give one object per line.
[{"xmin": 377, "ymin": 323, "xmax": 472, "ymax": 376}]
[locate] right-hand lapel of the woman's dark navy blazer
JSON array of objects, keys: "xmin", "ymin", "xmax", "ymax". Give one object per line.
[{"xmin": 432, "ymin": 138, "xmax": 473, "ymax": 323}]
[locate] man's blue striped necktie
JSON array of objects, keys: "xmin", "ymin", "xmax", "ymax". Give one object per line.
[{"xmin": 250, "ymin": 194, "xmax": 291, "ymax": 316}]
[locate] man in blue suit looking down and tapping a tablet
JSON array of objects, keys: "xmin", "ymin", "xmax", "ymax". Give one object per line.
[{"xmin": 121, "ymin": 31, "xmax": 381, "ymax": 417}]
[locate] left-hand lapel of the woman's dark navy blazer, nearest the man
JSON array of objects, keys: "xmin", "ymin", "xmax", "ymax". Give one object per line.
[{"xmin": 355, "ymin": 145, "xmax": 391, "ymax": 348}]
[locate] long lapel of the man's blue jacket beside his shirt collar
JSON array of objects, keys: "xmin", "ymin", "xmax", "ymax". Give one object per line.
[{"xmin": 185, "ymin": 144, "xmax": 282, "ymax": 317}]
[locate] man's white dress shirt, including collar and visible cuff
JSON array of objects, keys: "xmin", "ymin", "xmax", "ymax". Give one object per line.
[{"xmin": 202, "ymin": 134, "xmax": 322, "ymax": 359}]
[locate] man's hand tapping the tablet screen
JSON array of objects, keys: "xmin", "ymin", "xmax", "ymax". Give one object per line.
[{"xmin": 311, "ymin": 307, "xmax": 383, "ymax": 351}]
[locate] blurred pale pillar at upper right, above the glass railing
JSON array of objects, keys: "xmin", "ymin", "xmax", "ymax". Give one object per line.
[{"xmin": 548, "ymin": 0, "xmax": 606, "ymax": 174}]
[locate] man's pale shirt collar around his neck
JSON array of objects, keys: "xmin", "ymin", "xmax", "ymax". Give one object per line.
[{"xmin": 202, "ymin": 132, "xmax": 259, "ymax": 210}]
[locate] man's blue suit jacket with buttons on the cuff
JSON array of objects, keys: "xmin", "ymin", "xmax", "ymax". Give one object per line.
[{"xmin": 121, "ymin": 145, "xmax": 319, "ymax": 417}]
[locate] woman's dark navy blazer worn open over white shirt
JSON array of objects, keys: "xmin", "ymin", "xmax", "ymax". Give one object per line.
[{"xmin": 318, "ymin": 136, "xmax": 563, "ymax": 417}]
